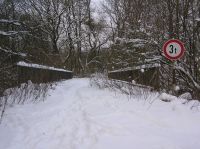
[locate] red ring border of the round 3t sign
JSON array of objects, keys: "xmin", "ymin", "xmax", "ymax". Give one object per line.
[{"xmin": 163, "ymin": 39, "xmax": 185, "ymax": 60}]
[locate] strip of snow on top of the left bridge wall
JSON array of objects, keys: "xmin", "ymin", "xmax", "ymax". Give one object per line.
[{"xmin": 17, "ymin": 61, "xmax": 72, "ymax": 72}]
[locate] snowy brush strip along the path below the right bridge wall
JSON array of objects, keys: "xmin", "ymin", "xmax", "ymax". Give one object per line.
[{"xmin": 90, "ymin": 73, "xmax": 200, "ymax": 110}]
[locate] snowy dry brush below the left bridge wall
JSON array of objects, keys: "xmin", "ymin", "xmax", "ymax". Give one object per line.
[{"xmin": 0, "ymin": 81, "xmax": 55, "ymax": 122}]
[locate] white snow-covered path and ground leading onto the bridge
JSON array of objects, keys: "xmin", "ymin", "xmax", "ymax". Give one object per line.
[{"xmin": 0, "ymin": 79, "xmax": 200, "ymax": 149}]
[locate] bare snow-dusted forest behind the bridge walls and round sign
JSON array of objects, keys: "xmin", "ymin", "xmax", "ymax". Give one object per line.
[{"xmin": 0, "ymin": 0, "xmax": 200, "ymax": 99}]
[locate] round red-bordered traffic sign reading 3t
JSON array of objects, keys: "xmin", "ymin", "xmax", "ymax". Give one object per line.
[{"xmin": 163, "ymin": 39, "xmax": 185, "ymax": 61}]
